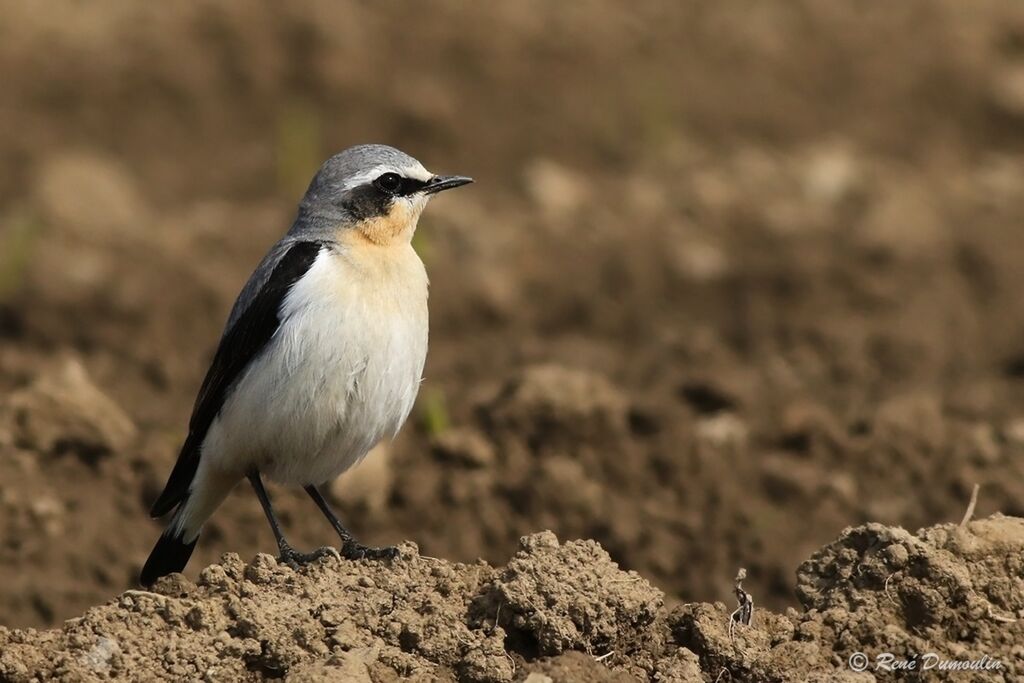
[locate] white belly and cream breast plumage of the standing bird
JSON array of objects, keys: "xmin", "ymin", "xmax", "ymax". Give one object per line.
[{"xmin": 175, "ymin": 245, "xmax": 428, "ymax": 541}]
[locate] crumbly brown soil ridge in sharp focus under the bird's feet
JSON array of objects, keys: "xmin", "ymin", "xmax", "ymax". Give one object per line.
[{"xmin": 0, "ymin": 515, "xmax": 1024, "ymax": 682}]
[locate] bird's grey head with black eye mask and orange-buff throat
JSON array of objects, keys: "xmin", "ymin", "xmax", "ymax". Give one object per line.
[{"xmin": 300, "ymin": 144, "xmax": 473, "ymax": 246}]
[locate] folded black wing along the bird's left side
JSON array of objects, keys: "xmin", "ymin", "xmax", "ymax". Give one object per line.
[{"xmin": 150, "ymin": 242, "xmax": 322, "ymax": 517}]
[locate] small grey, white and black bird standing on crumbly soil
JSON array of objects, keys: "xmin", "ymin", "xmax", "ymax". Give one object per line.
[{"xmin": 139, "ymin": 144, "xmax": 473, "ymax": 586}]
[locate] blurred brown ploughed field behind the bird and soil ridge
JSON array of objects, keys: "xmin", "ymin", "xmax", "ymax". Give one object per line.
[{"xmin": 0, "ymin": 0, "xmax": 1024, "ymax": 626}]
